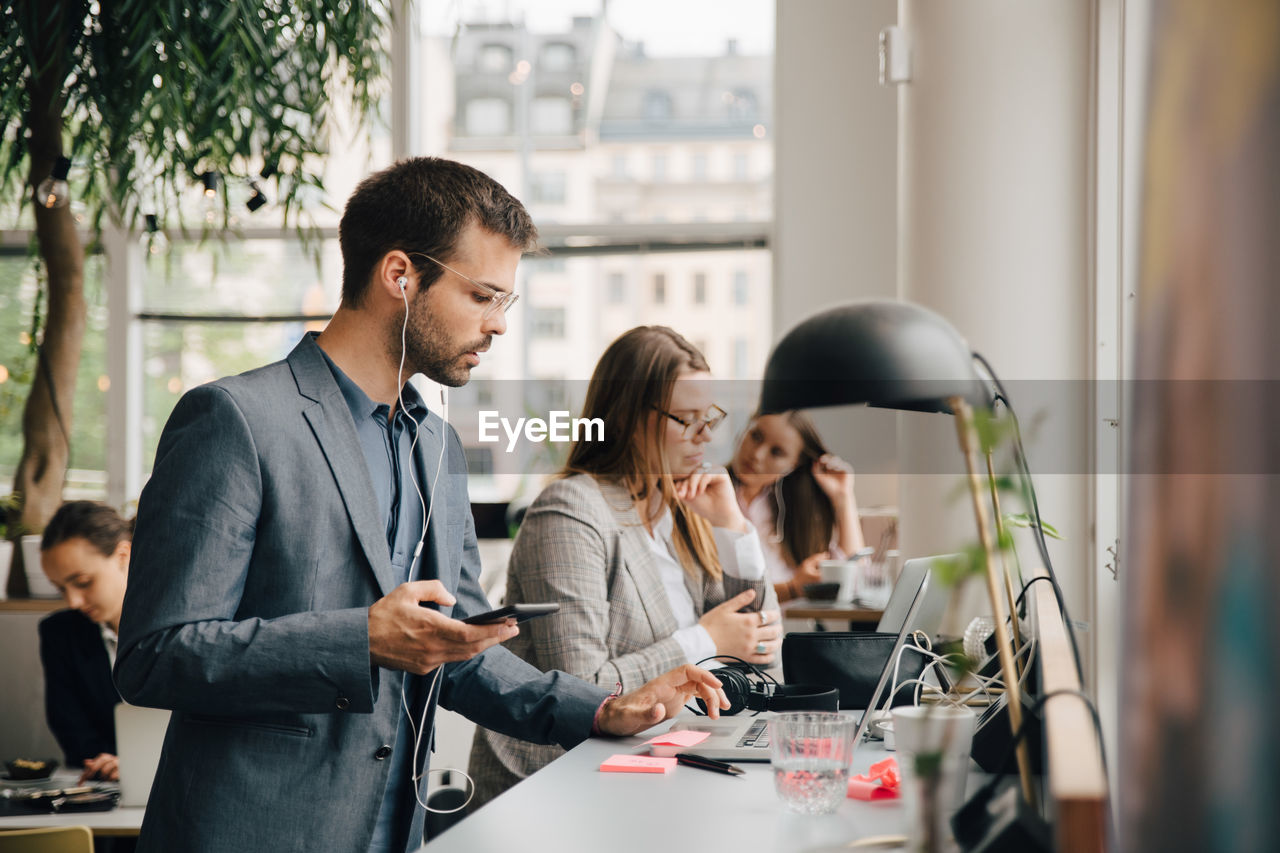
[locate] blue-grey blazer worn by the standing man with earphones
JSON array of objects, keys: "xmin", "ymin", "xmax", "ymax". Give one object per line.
[{"xmin": 115, "ymin": 337, "xmax": 608, "ymax": 853}]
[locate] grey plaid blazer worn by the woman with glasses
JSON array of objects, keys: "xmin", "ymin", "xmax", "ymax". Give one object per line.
[{"xmin": 468, "ymin": 475, "xmax": 778, "ymax": 807}]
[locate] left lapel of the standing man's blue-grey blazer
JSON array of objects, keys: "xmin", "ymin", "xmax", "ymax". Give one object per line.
[{"xmin": 288, "ymin": 336, "xmax": 397, "ymax": 596}]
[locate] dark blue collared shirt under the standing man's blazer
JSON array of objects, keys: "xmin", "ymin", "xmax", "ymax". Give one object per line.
[{"xmin": 321, "ymin": 350, "xmax": 431, "ymax": 853}]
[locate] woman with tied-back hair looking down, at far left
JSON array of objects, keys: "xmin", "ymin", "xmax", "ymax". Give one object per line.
[{"xmin": 40, "ymin": 501, "xmax": 133, "ymax": 781}]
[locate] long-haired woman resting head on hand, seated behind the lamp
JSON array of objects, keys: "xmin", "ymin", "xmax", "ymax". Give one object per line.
[{"xmin": 728, "ymin": 411, "xmax": 864, "ymax": 601}]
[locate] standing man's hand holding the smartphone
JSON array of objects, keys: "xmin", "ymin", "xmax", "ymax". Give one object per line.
[{"xmin": 369, "ymin": 580, "xmax": 517, "ymax": 676}]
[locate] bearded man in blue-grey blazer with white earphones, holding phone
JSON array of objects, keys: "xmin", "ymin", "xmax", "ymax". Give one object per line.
[{"xmin": 115, "ymin": 158, "xmax": 727, "ymax": 853}]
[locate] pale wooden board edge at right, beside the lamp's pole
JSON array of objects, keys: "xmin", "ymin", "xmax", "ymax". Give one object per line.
[{"xmin": 1029, "ymin": 569, "xmax": 1108, "ymax": 853}]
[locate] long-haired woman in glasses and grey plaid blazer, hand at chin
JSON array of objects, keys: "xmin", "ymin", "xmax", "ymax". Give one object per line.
[{"xmin": 471, "ymin": 325, "xmax": 781, "ymax": 807}]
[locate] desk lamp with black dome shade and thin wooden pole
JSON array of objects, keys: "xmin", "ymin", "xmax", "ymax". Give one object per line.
[{"xmin": 760, "ymin": 301, "xmax": 1034, "ymax": 802}]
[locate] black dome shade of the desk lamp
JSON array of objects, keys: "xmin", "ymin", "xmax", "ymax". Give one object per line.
[{"xmin": 760, "ymin": 300, "xmax": 988, "ymax": 414}]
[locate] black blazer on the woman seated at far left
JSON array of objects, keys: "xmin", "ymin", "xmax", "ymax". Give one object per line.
[{"xmin": 40, "ymin": 610, "xmax": 120, "ymax": 767}]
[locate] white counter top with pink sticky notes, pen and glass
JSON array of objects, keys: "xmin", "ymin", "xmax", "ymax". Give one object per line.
[{"xmin": 422, "ymin": 722, "xmax": 931, "ymax": 853}]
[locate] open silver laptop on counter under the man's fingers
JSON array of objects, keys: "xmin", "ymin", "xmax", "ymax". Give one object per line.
[{"xmin": 671, "ymin": 557, "xmax": 946, "ymax": 762}]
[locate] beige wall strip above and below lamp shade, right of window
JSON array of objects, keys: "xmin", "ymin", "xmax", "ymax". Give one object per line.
[{"xmin": 773, "ymin": 0, "xmax": 897, "ymax": 507}]
